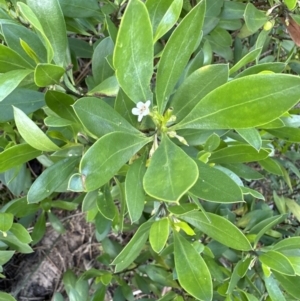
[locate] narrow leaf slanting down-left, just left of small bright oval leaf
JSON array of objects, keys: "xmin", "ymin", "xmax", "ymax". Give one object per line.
[{"xmin": 111, "ymin": 222, "xmax": 152, "ymax": 273}]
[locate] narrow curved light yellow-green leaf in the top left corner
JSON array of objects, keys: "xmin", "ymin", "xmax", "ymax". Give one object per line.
[{"xmin": 18, "ymin": 1, "xmax": 54, "ymax": 63}]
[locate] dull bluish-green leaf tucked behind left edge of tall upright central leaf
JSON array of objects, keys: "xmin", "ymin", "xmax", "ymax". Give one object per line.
[{"xmin": 92, "ymin": 37, "xmax": 114, "ymax": 84}]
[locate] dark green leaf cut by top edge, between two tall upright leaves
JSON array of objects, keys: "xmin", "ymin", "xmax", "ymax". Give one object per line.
[{"xmin": 59, "ymin": 0, "xmax": 100, "ymax": 18}]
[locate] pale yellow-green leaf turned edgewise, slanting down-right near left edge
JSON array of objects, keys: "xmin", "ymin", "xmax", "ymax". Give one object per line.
[{"xmin": 14, "ymin": 107, "xmax": 60, "ymax": 152}]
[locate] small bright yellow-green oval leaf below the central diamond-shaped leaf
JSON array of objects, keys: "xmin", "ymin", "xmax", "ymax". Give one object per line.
[{"xmin": 149, "ymin": 217, "xmax": 170, "ymax": 253}]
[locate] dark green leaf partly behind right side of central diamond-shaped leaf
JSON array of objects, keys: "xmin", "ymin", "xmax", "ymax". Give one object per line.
[{"xmin": 189, "ymin": 160, "xmax": 243, "ymax": 203}]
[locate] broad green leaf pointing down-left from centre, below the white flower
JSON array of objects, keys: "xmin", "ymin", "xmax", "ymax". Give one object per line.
[{"xmin": 80, "ymin": 132, "xmax": 151, "ymax": 191}]
